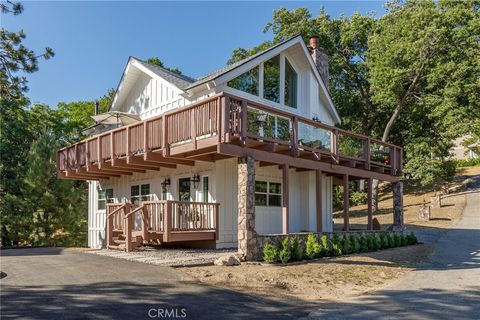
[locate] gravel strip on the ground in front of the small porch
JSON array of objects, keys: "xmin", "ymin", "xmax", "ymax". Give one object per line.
[{"xmin": 85, "ymin": 248, "xmax": 237, "ymax": 267}]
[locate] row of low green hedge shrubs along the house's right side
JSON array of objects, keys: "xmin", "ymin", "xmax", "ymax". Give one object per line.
[{"xmin": 263, "ymin": 233, "xmax": 417, "ymax": 264}]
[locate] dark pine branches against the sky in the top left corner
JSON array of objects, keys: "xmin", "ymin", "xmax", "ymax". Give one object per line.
[{"xmin": 0, "ymin": 1, "xmax": 55, "ymax": 99}]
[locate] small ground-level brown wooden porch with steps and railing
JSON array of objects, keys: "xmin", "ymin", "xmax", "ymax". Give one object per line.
[{"xmin": 107, "ymin": 200, "xmax": 219, "ymax": 252}]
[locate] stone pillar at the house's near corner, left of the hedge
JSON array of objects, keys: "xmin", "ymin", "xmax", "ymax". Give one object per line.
[{"xmin": 238, "ymin": 156, "xmax": 257, "ymax": 261}]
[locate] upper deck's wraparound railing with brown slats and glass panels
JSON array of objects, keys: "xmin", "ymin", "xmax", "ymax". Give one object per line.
[{"xmin": 57, "ymin": 93, "xmax": 402, "ymax": 175}]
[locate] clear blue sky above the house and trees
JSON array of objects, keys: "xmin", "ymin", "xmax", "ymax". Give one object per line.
[{"xmin": 1, "ymin": 1, "xmax": 384, "ymax": 106}]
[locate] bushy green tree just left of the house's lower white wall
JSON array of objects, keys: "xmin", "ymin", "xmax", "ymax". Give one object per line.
[{"xmin": 23, "ymin": 126, "xmax": 87, "ymax": 245}]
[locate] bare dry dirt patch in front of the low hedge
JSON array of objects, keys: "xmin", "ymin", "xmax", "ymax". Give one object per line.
[{"xmin": 181, "ymin": 244, "xmax": 432, "ymax": 301}]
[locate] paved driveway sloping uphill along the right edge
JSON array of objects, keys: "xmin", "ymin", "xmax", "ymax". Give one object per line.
[{"xmin": 309, "ymin": 189, "xmax": 480, "ymax": 320}]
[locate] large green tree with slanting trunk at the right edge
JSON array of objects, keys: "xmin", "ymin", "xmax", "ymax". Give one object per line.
[{"xmin": 367, "ymin": 1, "xmax": 480, "ymax": 192}]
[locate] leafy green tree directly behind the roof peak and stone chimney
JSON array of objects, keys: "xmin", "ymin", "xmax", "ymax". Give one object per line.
[{"xmin": 228, "ymin": 8, "xmax": 379, "ymax": 135}]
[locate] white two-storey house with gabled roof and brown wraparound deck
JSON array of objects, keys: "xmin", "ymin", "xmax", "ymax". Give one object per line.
[{"xmin": 58, "ymin": 36, "xmax": 401, "ymax": 260}]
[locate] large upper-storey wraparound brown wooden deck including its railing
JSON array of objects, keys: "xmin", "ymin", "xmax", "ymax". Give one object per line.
[{"xmin": 57, "ymin": 93, "xmax": 402, "ymax": 181}]
